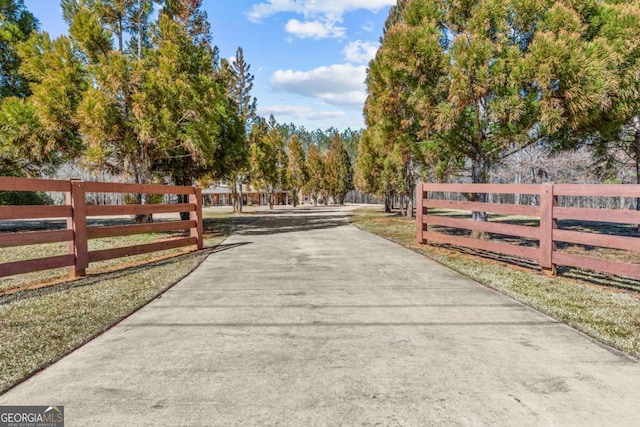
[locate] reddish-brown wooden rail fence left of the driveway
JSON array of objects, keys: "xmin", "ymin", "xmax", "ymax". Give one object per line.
[{"xmin": 0, "ymin": 177, "xmax": 203, "ymax": 277}]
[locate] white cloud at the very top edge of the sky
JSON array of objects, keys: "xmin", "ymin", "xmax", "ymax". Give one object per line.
[{"xmin": 247, "ymin": 0, "xmax": 396, "ymax": 39}]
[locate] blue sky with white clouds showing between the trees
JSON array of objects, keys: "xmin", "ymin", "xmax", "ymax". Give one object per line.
[{"xmin": 25, "ymin": 0, "xmax": 396, "ymax": 130}]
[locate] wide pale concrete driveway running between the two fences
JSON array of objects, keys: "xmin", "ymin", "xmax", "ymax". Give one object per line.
[{"xmin": 0, "ymin": 207, "xmax": 640, "ymax": 426}]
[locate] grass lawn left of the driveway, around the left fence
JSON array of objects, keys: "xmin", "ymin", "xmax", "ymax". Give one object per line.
[{"xmin": 0, "ymin": 213, "xmax": 253, "ymax": 393}]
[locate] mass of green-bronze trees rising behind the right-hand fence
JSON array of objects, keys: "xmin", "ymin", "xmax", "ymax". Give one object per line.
[{"xmin": 356, "ymin": 0, "xmax": 640, "ymax": 216}]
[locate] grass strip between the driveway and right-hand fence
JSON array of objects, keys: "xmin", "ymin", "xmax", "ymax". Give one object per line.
[{"xmin": 352, "ymin": 208, "xmax": 640, "ymax": 357}]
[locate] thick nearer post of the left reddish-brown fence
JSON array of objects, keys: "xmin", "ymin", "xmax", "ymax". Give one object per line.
[{"xmin": 67, "ymin": 179, "xmax": 89, "ymax": 278}]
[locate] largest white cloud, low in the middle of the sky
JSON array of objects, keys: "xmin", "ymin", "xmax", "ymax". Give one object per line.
[{"xmin": 270, "ymin": 64, "xmax": 367, "ymax": 108}]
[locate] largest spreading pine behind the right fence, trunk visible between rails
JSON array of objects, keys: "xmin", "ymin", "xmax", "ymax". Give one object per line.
[{"xmin": 367, "ymin": 0, "xmax": 616, "ymax": 219}]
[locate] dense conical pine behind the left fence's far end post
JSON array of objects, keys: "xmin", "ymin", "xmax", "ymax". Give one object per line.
[{"xmin": 137, "ymin": 1, "xmax": 235, "ymax": 217}]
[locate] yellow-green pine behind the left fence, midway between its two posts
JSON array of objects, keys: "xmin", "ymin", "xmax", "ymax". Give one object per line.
[{"xmin": 63, "ymin": 0, "xmax": 156, "ymax": 222}]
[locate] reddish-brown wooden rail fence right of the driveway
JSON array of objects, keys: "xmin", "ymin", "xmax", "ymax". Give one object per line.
[{"xmin": 416, "ymin": 183, "xmax": 640, "ymax": 279}]
